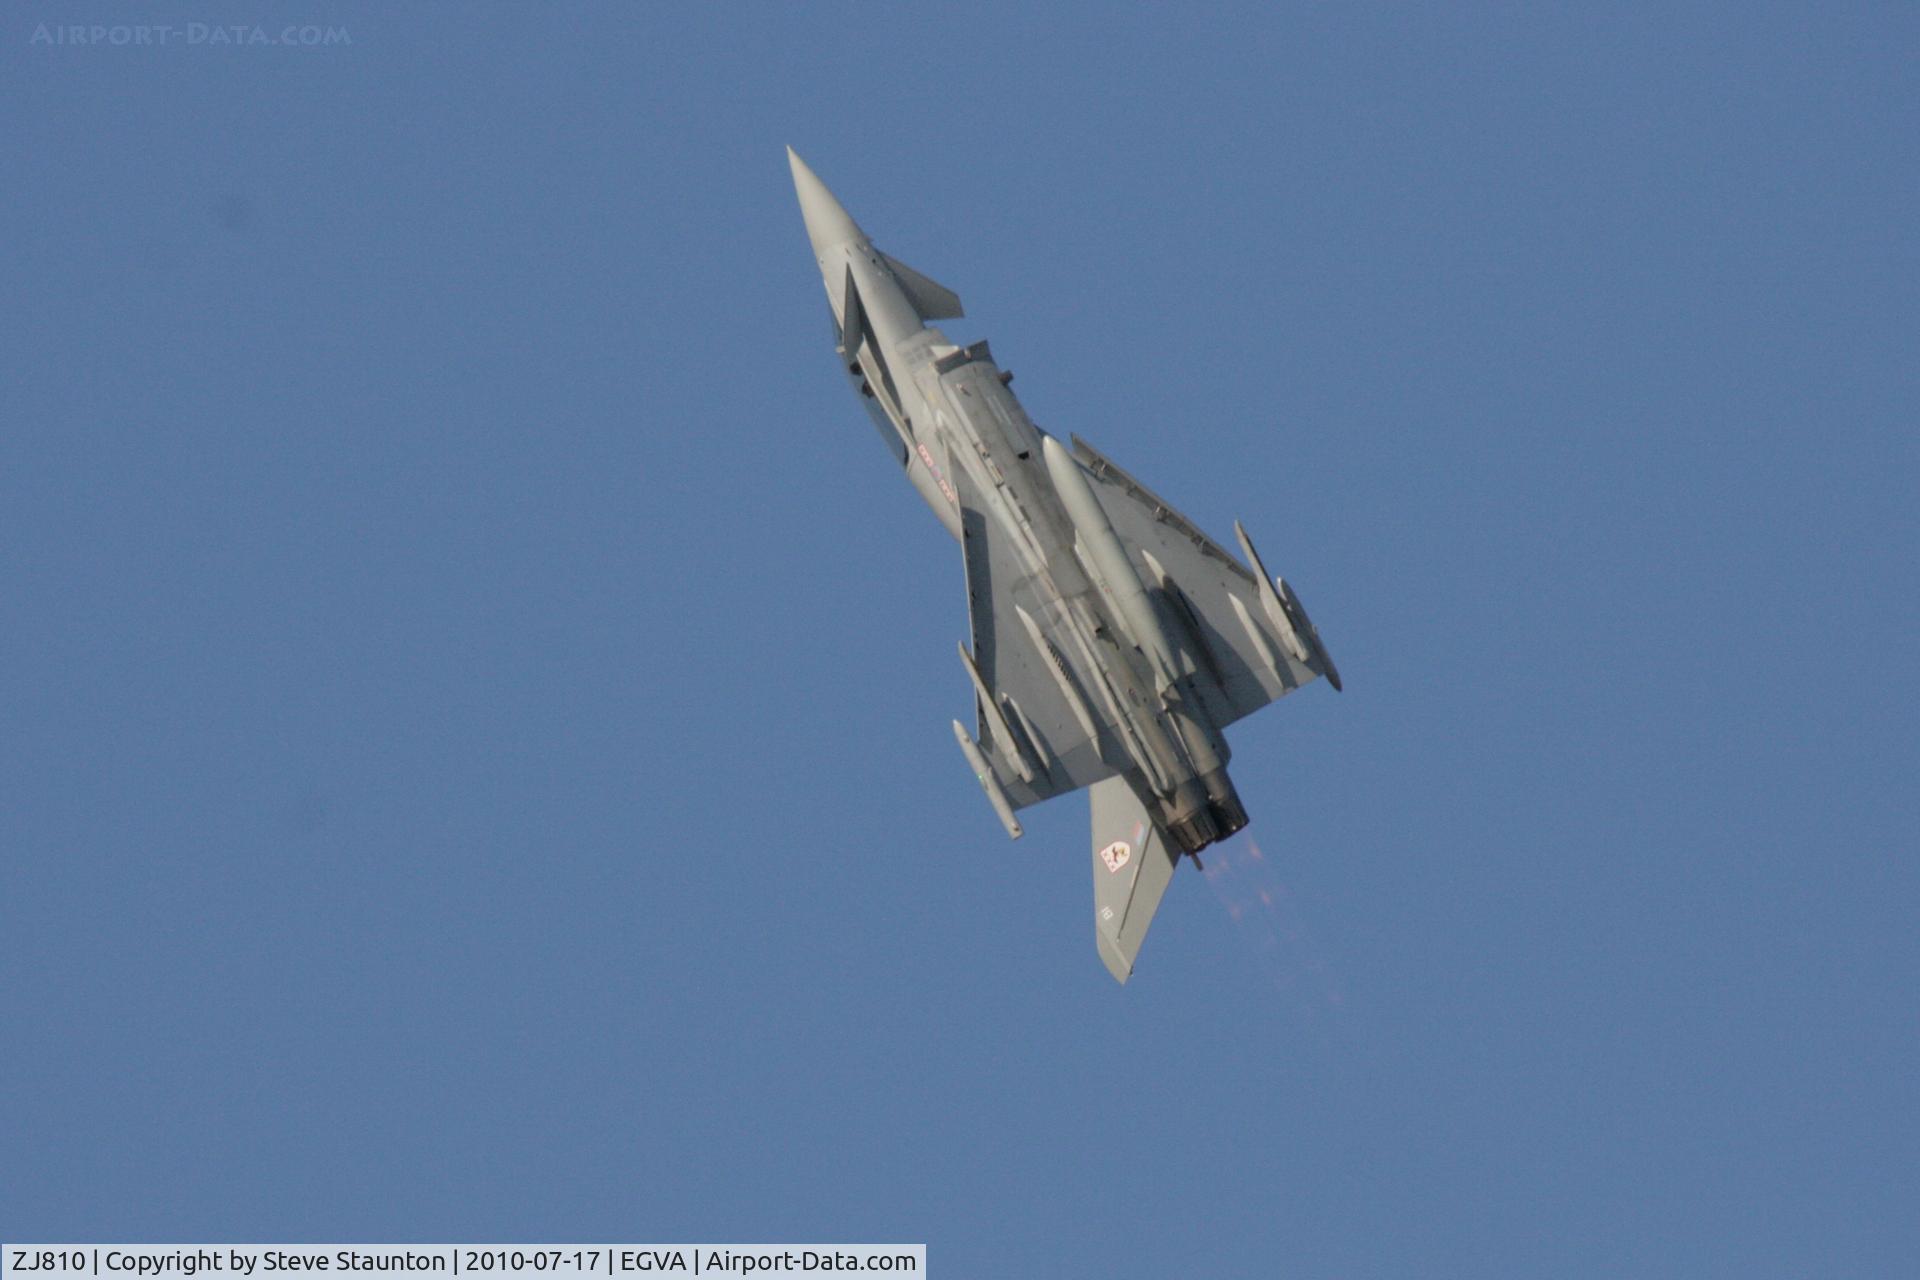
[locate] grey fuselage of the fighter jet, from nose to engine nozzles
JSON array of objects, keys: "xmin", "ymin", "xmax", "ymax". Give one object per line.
[{"xmin": 795, "ymin": 159, "xmax": 1246, "ymax": 852}]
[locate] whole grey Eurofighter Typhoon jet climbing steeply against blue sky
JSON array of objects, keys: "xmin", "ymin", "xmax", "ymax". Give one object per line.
[{"xmin": 787, "ymin": 148, "xmax": 1340, "ymax": 983}]
